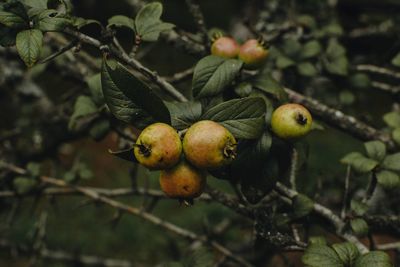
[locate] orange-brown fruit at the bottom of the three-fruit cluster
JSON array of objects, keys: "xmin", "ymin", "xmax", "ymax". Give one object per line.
[{"xmin": 160, "ymin": 160, "xmax": 206, "ymax": 199}]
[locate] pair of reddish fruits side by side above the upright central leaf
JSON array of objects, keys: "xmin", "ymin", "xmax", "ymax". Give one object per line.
[{"xmin": 211, "ymin": 36, "xmax": 268, "ymax": 70}]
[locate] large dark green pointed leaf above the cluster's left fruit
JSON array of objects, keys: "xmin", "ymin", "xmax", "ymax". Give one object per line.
[{"xmin": 101, "ymin": 60, "xmax": 171, "ymax": 128}]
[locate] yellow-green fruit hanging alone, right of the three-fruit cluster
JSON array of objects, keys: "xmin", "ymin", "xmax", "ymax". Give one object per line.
[{"xmin": 271, "ymin": 104, "xmax": 312, "ymax": 139}]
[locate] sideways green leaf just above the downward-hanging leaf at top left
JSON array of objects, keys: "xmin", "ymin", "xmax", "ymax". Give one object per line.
[{"xmin": 35, "ymin": 9, "xmax": 72, "ymax": 32}]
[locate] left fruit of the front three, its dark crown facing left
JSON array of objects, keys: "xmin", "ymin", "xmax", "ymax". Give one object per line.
[{"xmin": 134, "ymin": 122, "xmax": 182, "ymax": 170}]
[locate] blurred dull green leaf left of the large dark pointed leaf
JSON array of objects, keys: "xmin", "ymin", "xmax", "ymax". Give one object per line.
[{"xmin": 68, "ymin": 96, "xmax": 98, "ymax": 130}]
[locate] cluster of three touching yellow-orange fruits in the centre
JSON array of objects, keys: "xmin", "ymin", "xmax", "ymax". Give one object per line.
[{"xmin": 134, "ymin": 120, "xmax": 236, "ymax": 201}]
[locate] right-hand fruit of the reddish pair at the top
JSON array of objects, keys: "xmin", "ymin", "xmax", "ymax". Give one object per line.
[{"xmin": 239, "ymin": 39, "xmax": 268, "ymax": 70}]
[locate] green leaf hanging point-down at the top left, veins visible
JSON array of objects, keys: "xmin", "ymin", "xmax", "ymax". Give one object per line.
[{"xmin": 16, "ymin": 29, "xmax": 43, "ymax": 67}]
